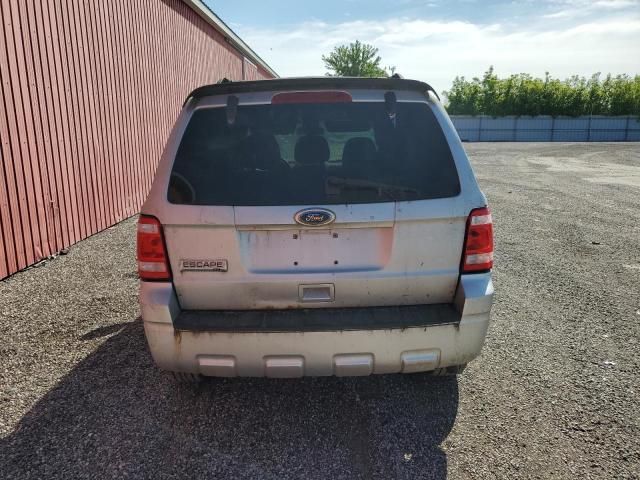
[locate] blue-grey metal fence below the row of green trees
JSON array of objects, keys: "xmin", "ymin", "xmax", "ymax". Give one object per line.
[{"xmin": 451, "ymin": 115, "xmax": 640, "ymax": 142}]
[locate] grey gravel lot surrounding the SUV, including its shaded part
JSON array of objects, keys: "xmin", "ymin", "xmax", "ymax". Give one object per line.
[{"xmin": 0, "ymin": 144, "xmax": 640, "ymax": 479}]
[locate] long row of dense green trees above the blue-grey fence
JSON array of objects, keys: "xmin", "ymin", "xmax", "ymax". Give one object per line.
[{"xmin": 444, "ymin": 67, "xmax": 640, "ymax": 117}]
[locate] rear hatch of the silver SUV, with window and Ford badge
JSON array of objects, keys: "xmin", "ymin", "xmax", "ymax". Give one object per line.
[{"xmin": 160, "ymin": 87, "xmax": 469, "ymax": 310}]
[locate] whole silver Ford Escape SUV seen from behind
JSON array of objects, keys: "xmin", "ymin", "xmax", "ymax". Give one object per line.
[{"xmin": 137, "ymin": 77, "xmax": 493, "ymax": 380}]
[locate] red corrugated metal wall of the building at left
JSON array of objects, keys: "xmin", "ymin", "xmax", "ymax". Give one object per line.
[{"xmin": 0, "ymin": 0, "xmax": 269, "ymax": 278}]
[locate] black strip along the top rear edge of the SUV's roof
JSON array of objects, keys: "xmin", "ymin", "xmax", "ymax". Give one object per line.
[{"xmin": 185, "ymin": 74, "xmax": 440, "ymax": 103}]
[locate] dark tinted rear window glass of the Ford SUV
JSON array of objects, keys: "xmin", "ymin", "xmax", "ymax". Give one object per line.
[{"xmin": 168, "ymin": 97, "xmax": 460, "ymax": 206}]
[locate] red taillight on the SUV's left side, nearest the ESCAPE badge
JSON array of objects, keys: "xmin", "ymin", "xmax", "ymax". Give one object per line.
[{"xmin": 137, "ymin": 215, "xmax": 171, "ymax": 280}]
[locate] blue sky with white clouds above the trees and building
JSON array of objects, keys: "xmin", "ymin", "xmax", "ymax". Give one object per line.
[{"xmin": 205, "ymin": 0, "xmax": 640, "ymax": 92}]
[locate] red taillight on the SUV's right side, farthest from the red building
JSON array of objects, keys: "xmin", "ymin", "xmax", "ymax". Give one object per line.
[{"xmin": 462, "ymin": 207, "xmax": 493, "ymax": 273}]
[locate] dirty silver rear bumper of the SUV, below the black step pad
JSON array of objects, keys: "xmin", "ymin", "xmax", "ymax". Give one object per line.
[{"xmin": 140, "ymin": 274, "xmax": 493, "ymax": 377}]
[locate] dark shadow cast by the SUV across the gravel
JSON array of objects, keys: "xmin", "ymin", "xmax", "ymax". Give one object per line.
[{"xmin": 0, "ymin": 320, "xmax": 458, "ymax": 479}]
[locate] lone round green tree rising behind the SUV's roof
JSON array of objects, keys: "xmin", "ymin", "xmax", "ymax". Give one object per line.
[{"xmin": 322, "ymin": 40, "xmax": 395, "ymax": 77}]
